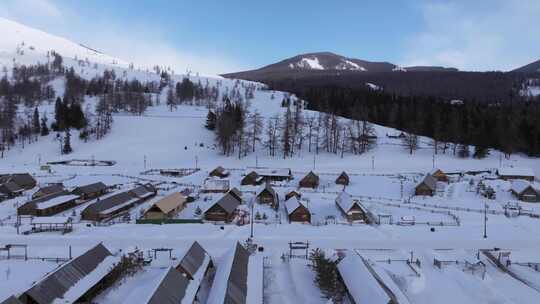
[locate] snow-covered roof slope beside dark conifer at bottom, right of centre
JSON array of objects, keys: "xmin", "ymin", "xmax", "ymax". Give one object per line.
[{"xmin": 337, "ymin": 253, "xmax": 392, "ymax": 304}]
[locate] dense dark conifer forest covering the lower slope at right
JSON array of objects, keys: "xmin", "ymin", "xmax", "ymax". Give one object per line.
[{"xmin": 270, "ymin": 86, "xmax": 540, "ymax": 157}]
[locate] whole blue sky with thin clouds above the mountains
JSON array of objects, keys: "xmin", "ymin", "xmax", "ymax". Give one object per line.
[{"xmin": 0, "ymin": 0, "xmax": 540, "ymax": 73}]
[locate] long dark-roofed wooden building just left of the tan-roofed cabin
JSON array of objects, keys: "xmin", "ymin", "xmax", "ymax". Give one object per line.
[{"xmin": 81, "ymin": 184, "xmax": 157, "ymax": 222}]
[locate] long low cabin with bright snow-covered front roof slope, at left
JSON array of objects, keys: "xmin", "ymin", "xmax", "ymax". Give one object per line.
[{"xmin": 17, "ymin": 191, "xmax": 79, "ymax": 216}]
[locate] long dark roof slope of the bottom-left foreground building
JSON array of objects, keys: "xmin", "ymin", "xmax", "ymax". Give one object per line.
[{"xmin": 25, "ymin": 243, "xmax": 112, "ymax": 304}]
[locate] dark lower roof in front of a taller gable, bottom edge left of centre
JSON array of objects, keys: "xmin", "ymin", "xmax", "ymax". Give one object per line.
[{"xmin": 146, "ymin": 267, "xmax": 191, "ymax": 304}]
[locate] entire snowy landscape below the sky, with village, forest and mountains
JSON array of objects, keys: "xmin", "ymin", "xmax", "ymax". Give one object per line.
[{"xmin": 0, "ymin": 1, "xmax": 540, "ymax": 304}]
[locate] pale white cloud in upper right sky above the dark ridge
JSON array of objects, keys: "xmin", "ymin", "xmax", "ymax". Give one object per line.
[{"xmin": 401, "ymin": 0, "xmax": 540, "ymax": 70}]
